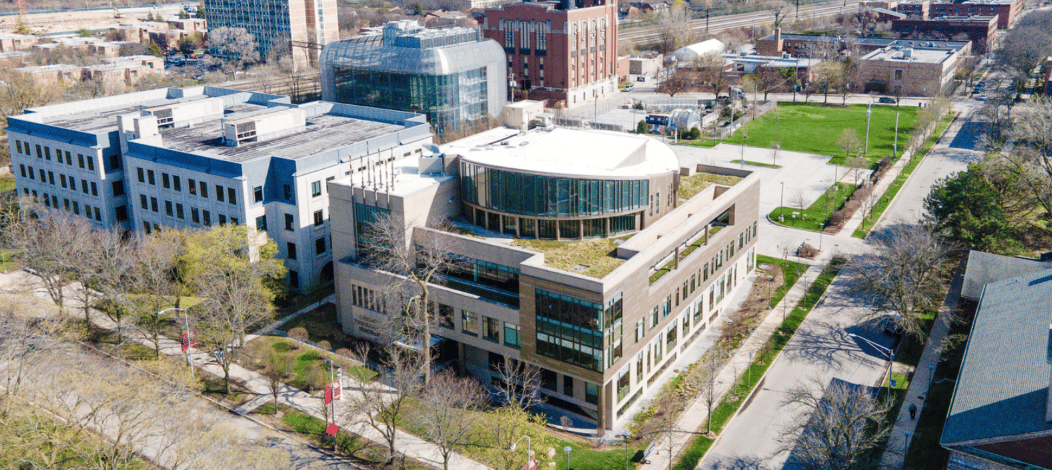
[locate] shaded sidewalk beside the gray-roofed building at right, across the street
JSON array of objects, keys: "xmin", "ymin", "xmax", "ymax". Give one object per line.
[{"xmin": 879, "ymin": 259, "xmax": 965, "ymax": 469}]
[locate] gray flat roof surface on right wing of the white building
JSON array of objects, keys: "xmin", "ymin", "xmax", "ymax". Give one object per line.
[{"xmin": 161, "ymin": 112, "xmax": 404, "ymax": 162}]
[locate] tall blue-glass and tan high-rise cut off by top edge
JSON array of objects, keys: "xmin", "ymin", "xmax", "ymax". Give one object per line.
[{"xmin": 204, "ymin": 0, "xmax": 340, "ymax": 64}]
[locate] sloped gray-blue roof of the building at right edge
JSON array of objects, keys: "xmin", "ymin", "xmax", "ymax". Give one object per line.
[{"xmin": 942, "ymin": 270, "xmax": 1052, "ymax": 446}]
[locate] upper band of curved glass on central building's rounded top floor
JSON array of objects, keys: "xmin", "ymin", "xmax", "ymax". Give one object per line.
[{"xmin": 461, "ymin": 162, "xmax": 649, "ymax": 217}]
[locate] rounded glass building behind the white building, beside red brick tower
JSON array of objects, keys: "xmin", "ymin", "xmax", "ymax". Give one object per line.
[{"xmin": 321, "ymin": 20, "xmax": 507, "ymax": 134}]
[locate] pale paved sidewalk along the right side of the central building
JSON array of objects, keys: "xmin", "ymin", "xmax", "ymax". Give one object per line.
[{"xmin": 639, "ymin": 250, "xmax": 833, "ymax": 470}]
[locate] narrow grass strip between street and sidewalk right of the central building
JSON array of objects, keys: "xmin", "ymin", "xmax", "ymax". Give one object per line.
[{"xmin": 672, "ymin": 259, "xmax": 844, "ymax": 470}]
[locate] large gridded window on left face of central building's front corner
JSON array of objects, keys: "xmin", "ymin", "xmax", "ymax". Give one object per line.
[{"xmin": 534, "ymin": 289, "xmax": 603, "ymax": 371}]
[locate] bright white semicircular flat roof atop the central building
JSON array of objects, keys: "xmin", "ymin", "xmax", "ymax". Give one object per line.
[{"xmin": 443, "ymin": 127, "xmax": 680, "ymax": 179}]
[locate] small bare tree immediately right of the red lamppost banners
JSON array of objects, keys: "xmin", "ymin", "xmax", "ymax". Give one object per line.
[{"xmin": 343, "ymin": 344, "xmax": 427, "ymax": 463}]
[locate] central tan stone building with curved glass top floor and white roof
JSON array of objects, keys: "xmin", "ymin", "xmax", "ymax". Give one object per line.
[{"xmin": 328, "ymin": 122, "xmax": 760, "ymax": 429}]
